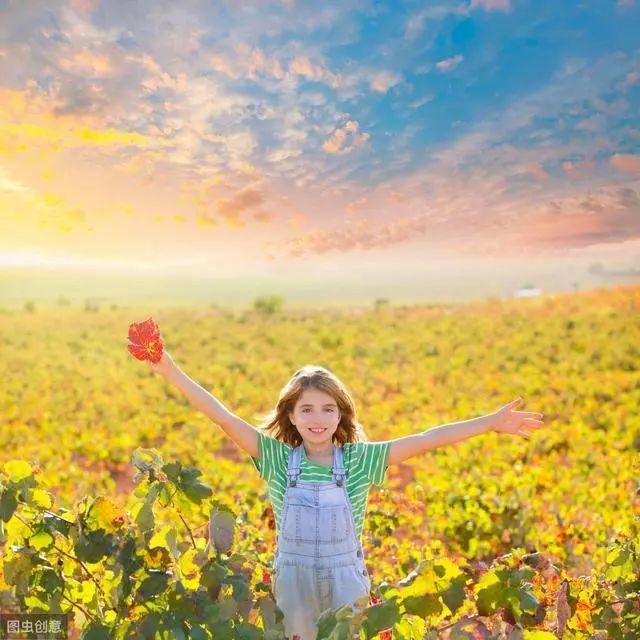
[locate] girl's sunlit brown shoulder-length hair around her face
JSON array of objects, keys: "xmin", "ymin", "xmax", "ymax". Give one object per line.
[{"xmin": 258, "ymin": 364, "xmax": 367, "ymax": 447}]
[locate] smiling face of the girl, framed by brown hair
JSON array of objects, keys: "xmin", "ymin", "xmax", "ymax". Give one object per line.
[{"xmin": 289, "ymin": 389, "xmax": 340, "ymax": 444}]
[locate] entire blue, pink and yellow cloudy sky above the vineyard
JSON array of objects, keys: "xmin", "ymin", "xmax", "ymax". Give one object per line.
[{"xmin": 0, "ymin": 0, "xmax": 640, "ymax": 304}]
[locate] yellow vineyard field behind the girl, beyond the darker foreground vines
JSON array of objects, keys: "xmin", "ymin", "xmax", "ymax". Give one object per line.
[{"xmin": 0, "ymin": 287, "xmax": 640, "ymax": 637}]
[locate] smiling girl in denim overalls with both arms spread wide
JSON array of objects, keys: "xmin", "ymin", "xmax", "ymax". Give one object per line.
[{"xmin": 149, "ymin": 351, "xmax": 543, "ymax": 640}]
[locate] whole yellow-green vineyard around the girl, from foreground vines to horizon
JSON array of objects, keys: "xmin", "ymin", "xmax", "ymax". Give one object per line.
[{"xmin": 0, "ymin": 287, "xmax": 640, "ymax": 640}]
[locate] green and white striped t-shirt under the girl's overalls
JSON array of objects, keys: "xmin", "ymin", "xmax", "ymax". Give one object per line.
[{"xmin": 251, "ymin": 431, "xmax": 391, "ymax": 537}]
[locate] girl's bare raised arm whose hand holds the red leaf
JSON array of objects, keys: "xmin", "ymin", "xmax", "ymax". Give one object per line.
[{"xmin": 147, "ymin": 351, "xmax": 259, "ymax": 458}]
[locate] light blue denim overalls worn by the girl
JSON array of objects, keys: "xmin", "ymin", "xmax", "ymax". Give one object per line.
[{"xmin": 272, "ymin": 444, "xmax": 371, "ymax": 640}]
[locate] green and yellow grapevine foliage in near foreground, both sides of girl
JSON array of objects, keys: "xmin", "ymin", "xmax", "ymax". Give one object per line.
[{"xmin": 0, "ymin": 449, "xmax": 640, "ymax": 640}]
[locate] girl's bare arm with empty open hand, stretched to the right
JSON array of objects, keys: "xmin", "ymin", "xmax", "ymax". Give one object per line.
[{"xmin": 388, "ymin": 398, "xmax": 544, "ymax": 464}]
